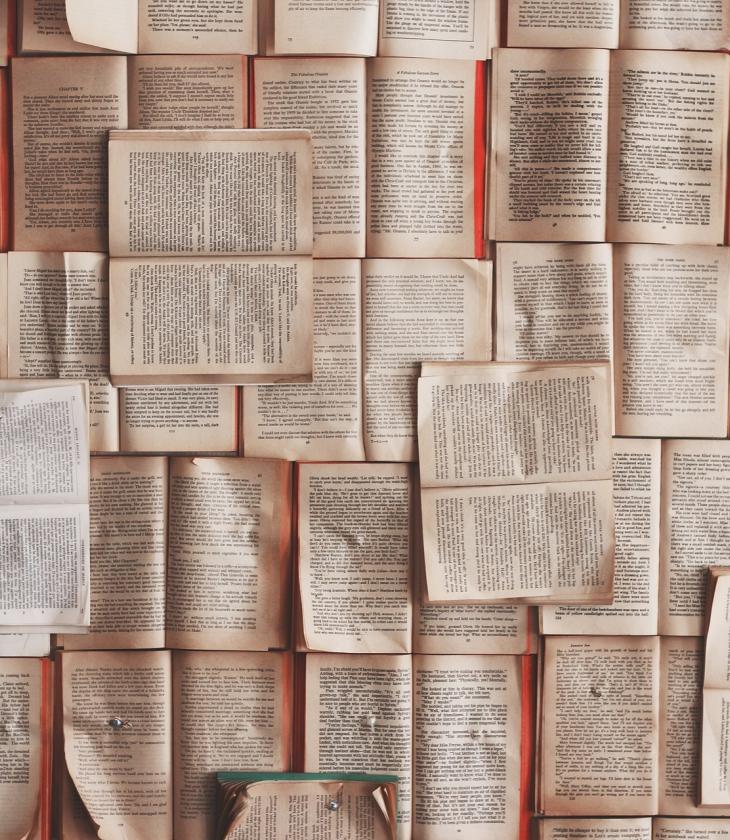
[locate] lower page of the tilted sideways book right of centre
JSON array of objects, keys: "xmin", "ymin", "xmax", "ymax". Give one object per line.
[{"xmin": 421, "ymin": 481, "xmax": 614, "ymax": 604}]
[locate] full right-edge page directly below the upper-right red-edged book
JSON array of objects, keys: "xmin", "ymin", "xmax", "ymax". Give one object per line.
[{"xmin": 614, "ymin": 245, "xmax": 730, "ymax": 437}]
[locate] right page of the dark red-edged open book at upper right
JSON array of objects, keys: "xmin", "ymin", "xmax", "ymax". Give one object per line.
[{"xmin": 607, "ymin": 50, "xmax": 730, "ymax": 245}]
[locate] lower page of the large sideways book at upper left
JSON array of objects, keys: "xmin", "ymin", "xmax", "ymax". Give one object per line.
[{"xmin": 109, "ymin": 257, "xmax": 313, "ymax": 385}]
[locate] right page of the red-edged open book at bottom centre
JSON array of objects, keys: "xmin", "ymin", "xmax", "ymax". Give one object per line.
[{"xmin": 413, "ymin": 656, "xmax": 522, "ymax": 840}]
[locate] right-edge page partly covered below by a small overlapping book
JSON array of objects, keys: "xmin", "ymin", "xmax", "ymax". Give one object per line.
[{"xmin": 659, "ymin": 440, "xmax": 730, "ymax": 636}]
